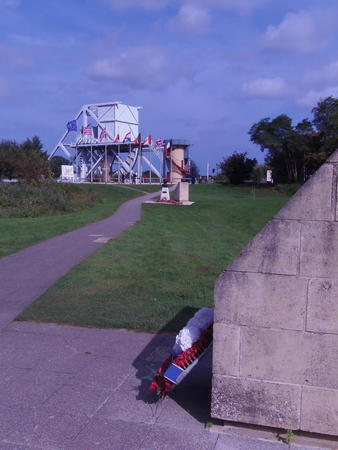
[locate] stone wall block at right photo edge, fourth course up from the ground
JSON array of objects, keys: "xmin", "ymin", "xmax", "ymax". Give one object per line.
[{"xmin": 300, "ymin": 222, "xmax": 338, "ymax": 278}]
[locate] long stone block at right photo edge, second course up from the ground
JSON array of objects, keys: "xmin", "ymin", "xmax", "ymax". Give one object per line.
[{"xmin": 240, "ymin": 328, "xmax": 338, "ymax": 389}]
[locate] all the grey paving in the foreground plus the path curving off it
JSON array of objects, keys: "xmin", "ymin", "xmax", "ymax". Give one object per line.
[{"xmin": 0, "ymin": 194, "xmax": 328, "ymax": 450}]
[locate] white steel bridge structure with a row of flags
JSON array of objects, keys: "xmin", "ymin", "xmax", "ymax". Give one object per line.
[{"xmin": 49, "ymin": 102, "xmax": 190, "ymax": 183}]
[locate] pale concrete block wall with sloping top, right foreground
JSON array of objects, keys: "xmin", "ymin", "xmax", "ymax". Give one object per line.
[{"xmin": 212, "ymin": 151, "xmax": 338, "ymax": 435}]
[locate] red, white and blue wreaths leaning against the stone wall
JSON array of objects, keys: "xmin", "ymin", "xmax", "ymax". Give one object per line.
[{"xmin": 149, "ymin": 308, "xmax": 214, "ymax": 397}]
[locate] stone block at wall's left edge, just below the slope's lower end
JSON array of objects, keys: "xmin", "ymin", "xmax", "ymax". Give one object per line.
[{"xmin": 215, "ymin": 271, "xmax": 308, "ymax": 330}]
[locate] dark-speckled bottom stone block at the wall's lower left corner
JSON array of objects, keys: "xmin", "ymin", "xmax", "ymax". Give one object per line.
[{"xmin": 211, "ymin": 375, "xmax": 301, "ymax": 430}]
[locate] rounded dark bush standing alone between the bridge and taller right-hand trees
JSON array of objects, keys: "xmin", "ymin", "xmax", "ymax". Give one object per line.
[{"xmin": 217, "ymin": 152, "xmax": 257, "ymax": 184}]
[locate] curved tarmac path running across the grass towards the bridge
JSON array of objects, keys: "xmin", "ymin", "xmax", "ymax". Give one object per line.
[{"xmin": 0, "ymin": 188, "xmax": 159, "ymax": 329}]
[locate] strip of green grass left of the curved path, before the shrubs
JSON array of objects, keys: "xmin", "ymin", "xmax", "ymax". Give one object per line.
[{"xmin": 0, "ymin": 184, "xmax": 160, "ymax": 257}]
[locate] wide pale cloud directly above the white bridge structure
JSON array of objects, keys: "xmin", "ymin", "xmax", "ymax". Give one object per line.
[{"xmin": 86, "ymin": 46, "xmax": 186, "ymax": 89}]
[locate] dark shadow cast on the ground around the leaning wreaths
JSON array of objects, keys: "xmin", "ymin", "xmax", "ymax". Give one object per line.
[{"xmin": 133, "ymin": 306, "xmax": 212, "ymax": 424}]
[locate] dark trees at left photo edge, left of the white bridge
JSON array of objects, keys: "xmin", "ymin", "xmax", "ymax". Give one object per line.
[{"xmin": 0, "ymin": 136, "xmax": 69, "ymax": 185}]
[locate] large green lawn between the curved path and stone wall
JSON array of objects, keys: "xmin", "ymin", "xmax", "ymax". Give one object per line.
[{"xmin": 19, "ymin": 185, "xmax": 288, "ymax": 331}]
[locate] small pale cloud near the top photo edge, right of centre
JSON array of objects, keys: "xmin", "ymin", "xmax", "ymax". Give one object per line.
[{"xmin": 172, "ymin": 4, "xmax": 210, "ymax": 33}]
